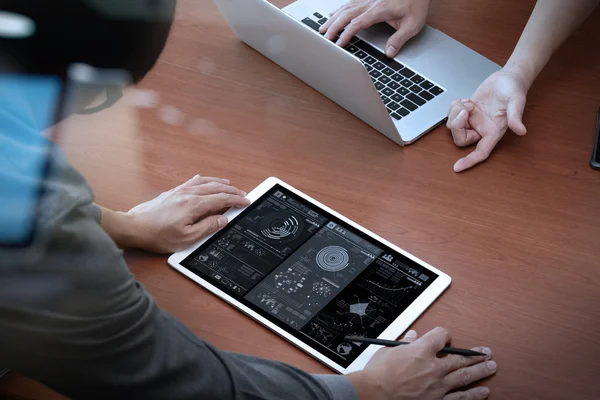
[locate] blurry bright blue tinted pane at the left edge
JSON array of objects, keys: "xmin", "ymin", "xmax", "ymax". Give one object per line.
[{"xmin": 0, "ymin": 75, "xmax": 60, "ymax": 244}]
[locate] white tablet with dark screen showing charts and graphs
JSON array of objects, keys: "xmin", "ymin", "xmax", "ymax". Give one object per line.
[{"xmin": 169, "ymin": 178, "xmax": 450, "ymax": 373}]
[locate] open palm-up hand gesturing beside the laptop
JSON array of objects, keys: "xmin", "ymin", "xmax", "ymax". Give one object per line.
[{"xmin": 447, "ymin": 69, "xmax": 527, "ymax": 172}]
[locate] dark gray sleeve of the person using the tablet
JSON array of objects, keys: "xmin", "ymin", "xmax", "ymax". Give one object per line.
[{"xmin": 0, "ymin": 153, "xmax": 357, "ymax": 400}]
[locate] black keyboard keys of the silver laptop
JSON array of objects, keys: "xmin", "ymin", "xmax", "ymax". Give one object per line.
[{"xmin": 302, "ymin": 12, "xmax": 444, "ymax": 121}]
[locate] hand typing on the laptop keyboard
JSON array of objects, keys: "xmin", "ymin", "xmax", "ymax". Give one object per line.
[{"xmin": 320, "ymin": 0, "xmax": 431, "ymax": 58}]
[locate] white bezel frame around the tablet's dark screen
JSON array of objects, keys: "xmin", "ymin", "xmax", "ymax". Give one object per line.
[{"xmin": 169, "ymin": 177, "xmax": 451, "ymax": 374}]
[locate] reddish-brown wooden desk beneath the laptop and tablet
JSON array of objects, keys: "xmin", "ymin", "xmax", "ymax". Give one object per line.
[{"xmin": 0, "ymin": 0, "xmax": 600, "ymax": 400}]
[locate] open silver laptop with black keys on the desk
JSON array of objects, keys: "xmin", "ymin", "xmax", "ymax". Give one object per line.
[{"xmin": 214, "ymin": 0, "xmax": 500, "ymax": 145}]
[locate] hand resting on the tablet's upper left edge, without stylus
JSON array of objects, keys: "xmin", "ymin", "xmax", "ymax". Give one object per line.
[{"xmin": 117, "ymin": 175, "xmax": 250, "ymax": 253}]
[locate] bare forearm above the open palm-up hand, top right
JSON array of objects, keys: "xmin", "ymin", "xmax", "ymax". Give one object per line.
[{"xmin": 504, "ymin": 0, "xmax": 599, "ymax": 89}]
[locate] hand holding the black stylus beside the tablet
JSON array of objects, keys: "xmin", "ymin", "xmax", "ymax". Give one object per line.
[{"xmin": 347, "ymin": 328, "xmax": 497, "ymax": 400}]
